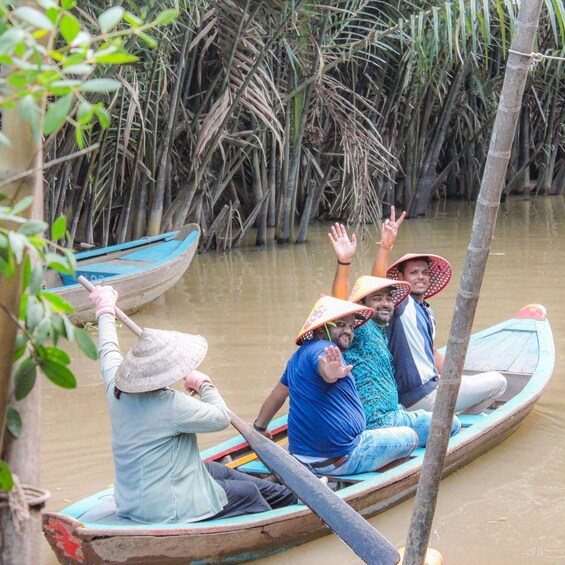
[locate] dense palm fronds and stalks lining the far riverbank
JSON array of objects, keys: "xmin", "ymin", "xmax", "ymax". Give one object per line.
[{"xmin": 41, "ymin": 0, "xmax": 565, "ymax": 250}]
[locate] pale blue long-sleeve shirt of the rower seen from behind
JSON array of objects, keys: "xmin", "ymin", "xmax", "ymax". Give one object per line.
[{"xmin": 98, "ymin": 314, "xmax": 230, "ymax": 523}]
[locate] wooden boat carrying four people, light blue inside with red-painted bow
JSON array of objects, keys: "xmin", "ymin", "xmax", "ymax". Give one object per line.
[{"xmin": 43, "ymin": 305, "xmax": 555, "ymax": 565}]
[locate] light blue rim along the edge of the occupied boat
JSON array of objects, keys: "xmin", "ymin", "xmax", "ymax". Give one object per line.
[{"xmin": 44, "ymin": 308, "xmax": 555, "ymax": 541}]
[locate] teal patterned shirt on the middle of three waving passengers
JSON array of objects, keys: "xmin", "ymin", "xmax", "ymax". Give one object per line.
[{"xmin": 344, "ymin": 320, "xmax": 402, "ymax": 430}]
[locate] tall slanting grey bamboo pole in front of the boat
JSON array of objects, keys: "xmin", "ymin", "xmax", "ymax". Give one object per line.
[{"xmin": 403, "ymin": 0, "xmax": 543, "ymax": 565}]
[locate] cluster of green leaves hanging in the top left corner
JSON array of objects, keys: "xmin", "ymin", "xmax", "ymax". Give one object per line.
[{"xmin": 0, "ymin": 0, "xmax": 178, "ymax": 148}]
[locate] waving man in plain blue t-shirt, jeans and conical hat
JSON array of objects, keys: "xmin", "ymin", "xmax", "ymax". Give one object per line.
[{"xmin": 254, "ymin": 296, "xmax": 418, "ymax": 475}]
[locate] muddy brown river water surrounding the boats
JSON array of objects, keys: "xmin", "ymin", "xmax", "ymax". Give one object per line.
[{"xmin": 43, "ymin": 197, "xmax": 565, "ymax": 565}]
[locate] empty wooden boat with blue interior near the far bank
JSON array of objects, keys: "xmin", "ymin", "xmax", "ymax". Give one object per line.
[{"xmin": 45, "ymin": 224, "xmax": 200, "ymax": 324}]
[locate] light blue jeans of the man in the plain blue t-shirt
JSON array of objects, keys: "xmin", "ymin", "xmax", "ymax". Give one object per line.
[{"xmin": 314, "ymin": 427, "xmax": 418, "ymax": 476}]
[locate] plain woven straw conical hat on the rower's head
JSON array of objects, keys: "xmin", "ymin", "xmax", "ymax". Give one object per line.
[{"xmin": 115, "ymin": 329, "xmax": 208, "ymax": 392}]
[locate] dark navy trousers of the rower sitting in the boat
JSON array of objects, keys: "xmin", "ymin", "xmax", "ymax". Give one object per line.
[{"xmin": 204, "ymin": 461, "xmax": 297, "ymax": 519}]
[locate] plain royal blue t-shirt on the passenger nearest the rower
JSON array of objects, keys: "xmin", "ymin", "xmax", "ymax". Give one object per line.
[{"xmin": 280, "ymin": 339, "xmax": 365, "ymax": 459}]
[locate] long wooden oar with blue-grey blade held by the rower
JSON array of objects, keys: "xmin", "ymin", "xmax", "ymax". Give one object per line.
[{"xmin": 77, "ymin": 276, "xmax": 400, "ymax": 565}]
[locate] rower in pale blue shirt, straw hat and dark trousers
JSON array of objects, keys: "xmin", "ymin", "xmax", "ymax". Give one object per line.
[{"xmin": 90, "ymin": 286, "xmax": 297, "ymax": 523}]
